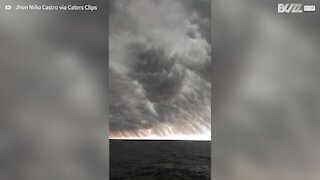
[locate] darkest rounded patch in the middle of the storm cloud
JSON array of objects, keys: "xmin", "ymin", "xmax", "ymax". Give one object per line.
[{"xmin": 130, "ymin": 44, "xmax": 185, "ymax": 102}]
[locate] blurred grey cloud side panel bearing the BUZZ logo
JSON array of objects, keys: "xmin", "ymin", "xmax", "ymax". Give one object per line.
[{"xmin": 212, "ymin": 0, "xmax": 320, "ymax": 180}]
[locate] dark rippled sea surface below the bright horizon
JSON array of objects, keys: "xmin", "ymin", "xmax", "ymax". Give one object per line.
[{"xmin": 110, "ymin": 140, "xmax": 211, "ymax": 180}]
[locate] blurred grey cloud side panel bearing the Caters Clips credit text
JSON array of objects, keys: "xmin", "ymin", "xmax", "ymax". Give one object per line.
[{"xmin": 0, "ymin": 0, "xmax": 109, "ymax": 180}]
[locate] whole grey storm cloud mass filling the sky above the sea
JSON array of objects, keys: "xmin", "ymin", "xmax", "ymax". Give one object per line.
[{"xmin": 109, "ymin": 0, "xmax": 211, "ymax": 136}]
